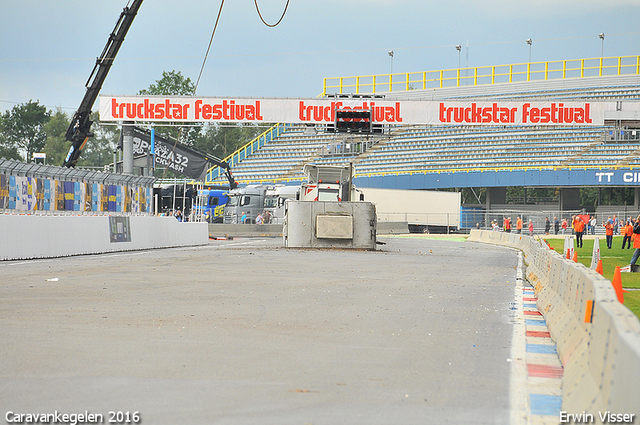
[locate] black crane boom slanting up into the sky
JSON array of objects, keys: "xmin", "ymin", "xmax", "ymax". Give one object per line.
[{"xmin": 63, "ymin": 0, "xmax": 143, "ymax": 167}]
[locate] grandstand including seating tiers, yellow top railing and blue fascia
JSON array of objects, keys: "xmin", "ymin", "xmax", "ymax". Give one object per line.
[{"xmin": 208, "ymin": 56, "xmax": 640, "ymax": 222}]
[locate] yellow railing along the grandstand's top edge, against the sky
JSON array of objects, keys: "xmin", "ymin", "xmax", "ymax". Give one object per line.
[{"xmin": 322, "ymin": 56, "xmax": 640, "ymax": 95}]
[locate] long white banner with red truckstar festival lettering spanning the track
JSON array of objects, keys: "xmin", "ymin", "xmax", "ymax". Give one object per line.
[{"xmin": 100, "ymin": 96, "xmax": 616, "ymax": 125}]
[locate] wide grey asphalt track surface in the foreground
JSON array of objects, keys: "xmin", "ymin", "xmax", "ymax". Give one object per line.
[{"xmin": 0, "ymin": 237, "xmax": 517, "ymax": 425}]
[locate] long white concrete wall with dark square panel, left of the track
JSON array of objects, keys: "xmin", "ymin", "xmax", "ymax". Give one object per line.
[{"xmin": 0, "ymin": 215, "xmax": 209, "ymax": 260}]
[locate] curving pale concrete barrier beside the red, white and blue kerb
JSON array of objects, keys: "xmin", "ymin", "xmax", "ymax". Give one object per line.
[{"xmin": 468, "ymin": 230, "xmax": 640, "ymax": 423}]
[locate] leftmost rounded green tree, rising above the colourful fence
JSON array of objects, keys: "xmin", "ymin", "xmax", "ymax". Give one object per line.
[{"xmin": 2, "ymin": 100, "xmax": 50, "ymax": 162}]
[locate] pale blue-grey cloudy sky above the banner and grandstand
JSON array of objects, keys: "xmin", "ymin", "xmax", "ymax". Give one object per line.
[{"xmin": 0, "ymin": 0, "xmax": 640, "ymax": 114}]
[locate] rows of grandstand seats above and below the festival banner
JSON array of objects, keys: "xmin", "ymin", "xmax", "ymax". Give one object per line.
[{"xmin": 208, "ymin": 77, "xmax": 640, "ymax": 183}]
